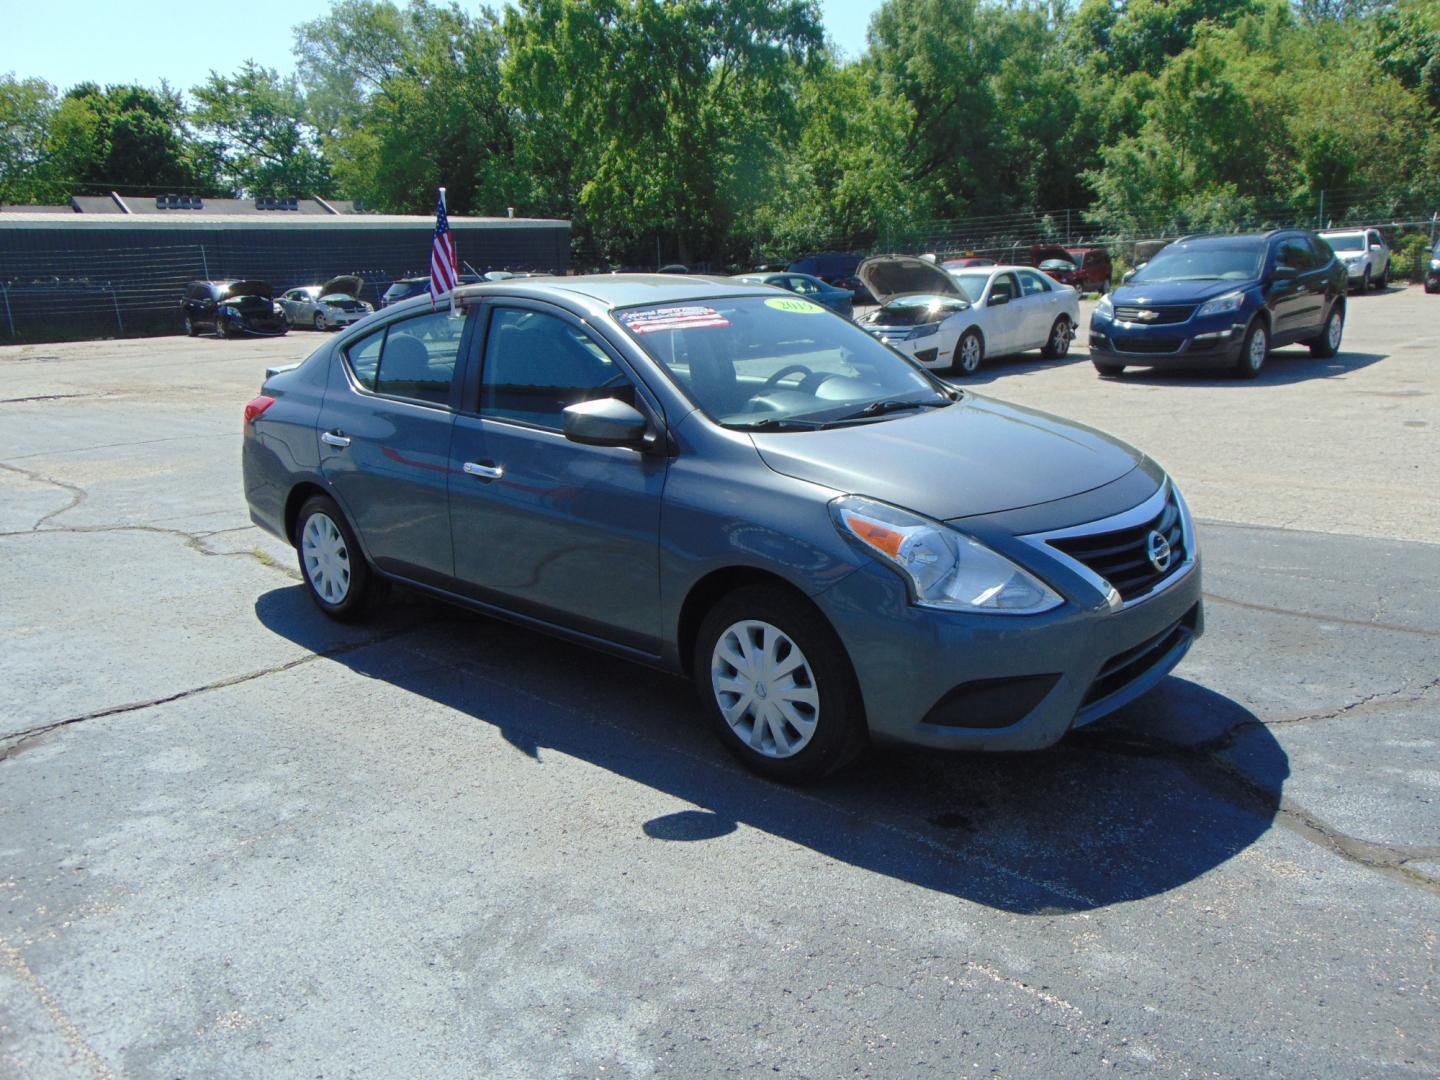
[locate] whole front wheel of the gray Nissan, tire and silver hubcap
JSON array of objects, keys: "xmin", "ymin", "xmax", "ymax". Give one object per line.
[{"xmin": 694, "ymin": 586, "xmax": 865, "ymax": 783}]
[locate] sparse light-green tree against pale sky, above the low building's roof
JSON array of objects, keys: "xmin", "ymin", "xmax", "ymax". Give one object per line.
[{"xmin": 190, "ymin": 60, "xmax": 334, "ymax": 196}]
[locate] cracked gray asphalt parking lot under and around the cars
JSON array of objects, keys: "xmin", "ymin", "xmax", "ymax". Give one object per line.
[{"xmin": 0, "ymin": 288, "xmax": 1440, "ymax": 1077}]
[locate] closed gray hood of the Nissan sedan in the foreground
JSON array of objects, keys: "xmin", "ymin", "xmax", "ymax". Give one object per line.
[{"xmin": 752, "ymin": 395, "xmax": 1143, "ymax": 521}]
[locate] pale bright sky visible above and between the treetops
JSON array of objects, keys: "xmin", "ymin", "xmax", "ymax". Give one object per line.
[{"xmin": 0, "ymin": 0, "xmax": 880, "ymax": 92}]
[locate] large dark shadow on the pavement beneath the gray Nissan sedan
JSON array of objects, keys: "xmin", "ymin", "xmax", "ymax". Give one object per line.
[{"xmin": 255, "ymin": 586, "xmax": 1289, "ymax": 914}]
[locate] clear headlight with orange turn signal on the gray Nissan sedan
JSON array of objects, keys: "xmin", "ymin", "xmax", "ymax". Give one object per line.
[{"xmin": 829, "ymin": 495, "xmax": 1061, "ymax": 615}]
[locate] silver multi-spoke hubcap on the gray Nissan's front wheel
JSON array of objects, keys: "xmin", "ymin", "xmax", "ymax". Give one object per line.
[{"xmin": 710, "ymin": 619, "xmax": 819, "ymax": 757}]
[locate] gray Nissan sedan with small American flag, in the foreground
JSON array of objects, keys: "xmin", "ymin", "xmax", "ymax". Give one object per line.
[{"xmin": 243, "ymin": 275, "xmax": 1202, "ymax": 780}]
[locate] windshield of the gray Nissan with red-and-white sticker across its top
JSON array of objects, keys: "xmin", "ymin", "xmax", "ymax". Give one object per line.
[{"xmin": 615, "ymin": 297, "xmax": 955, "ymax": 431}]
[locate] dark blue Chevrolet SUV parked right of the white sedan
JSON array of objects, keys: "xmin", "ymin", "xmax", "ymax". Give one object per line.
[{"xmin": 1090, "ymin": 229, "xmax": 1348, "ymax": 379}]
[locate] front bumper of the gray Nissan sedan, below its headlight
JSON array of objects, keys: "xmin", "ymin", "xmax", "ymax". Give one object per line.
[{"xmin": 814, "ymin": 489, "xmax": 1204, "ymax": 750}]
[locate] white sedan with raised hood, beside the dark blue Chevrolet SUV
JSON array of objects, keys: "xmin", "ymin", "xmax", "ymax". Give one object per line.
[{"xmin": 858, "ymin": 255, "xmax": 1080, "ymax": 374}]
